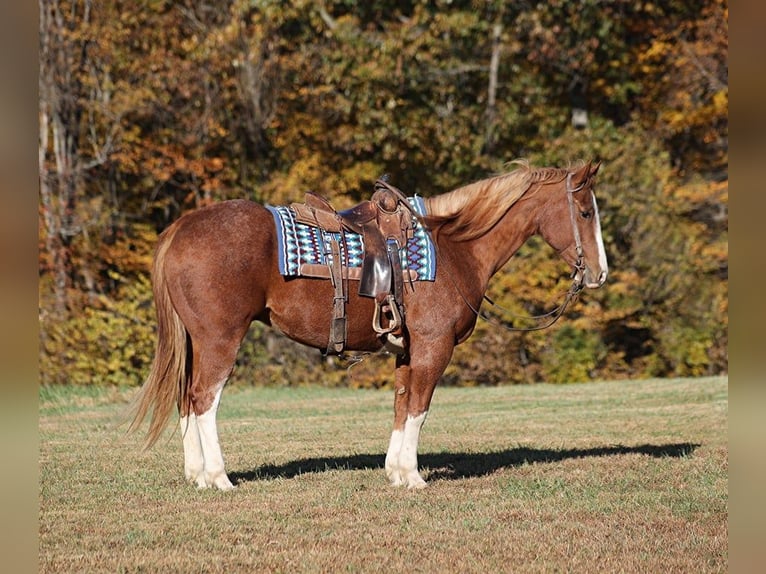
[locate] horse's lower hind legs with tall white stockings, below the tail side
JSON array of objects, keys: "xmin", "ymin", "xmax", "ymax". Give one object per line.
[{"xmin": 181, "ymin": 337, "xmax": 241, "ymax": 490}]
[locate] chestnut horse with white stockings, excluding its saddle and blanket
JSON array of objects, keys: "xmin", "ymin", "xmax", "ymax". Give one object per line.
[{"xmin": 130, "ymin": 160, "xmax": 608, "ymax": 490}]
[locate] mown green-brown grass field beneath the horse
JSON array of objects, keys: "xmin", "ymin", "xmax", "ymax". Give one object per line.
[{"xmin": 39, "ymin": 377, "xmax": 728, "ymax": 574}]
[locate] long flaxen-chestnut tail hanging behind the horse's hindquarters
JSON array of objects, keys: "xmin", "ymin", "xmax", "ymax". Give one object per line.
[{"xmin": 129, "ymin": 225, "xmax": 191, "ymax": 448}]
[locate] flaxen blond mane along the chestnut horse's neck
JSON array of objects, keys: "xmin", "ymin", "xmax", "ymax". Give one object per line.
[{"xmin": 425, "ymin": 160, "xmax": 568, "ymax": 240}]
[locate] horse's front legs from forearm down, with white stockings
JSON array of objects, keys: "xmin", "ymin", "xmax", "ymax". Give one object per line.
[{"xmin": 386, "ymin": 343, "xmax": 453, "ymax": 488}]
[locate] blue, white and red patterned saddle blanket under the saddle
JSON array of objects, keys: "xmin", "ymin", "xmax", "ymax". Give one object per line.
[{"xmin": 266, "ymin": 196, "xmax": 436, "ymax": 281}]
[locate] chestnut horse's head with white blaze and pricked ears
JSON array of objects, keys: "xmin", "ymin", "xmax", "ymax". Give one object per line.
[{"xmin": 539, "ymin": 163, "xmax": 609, "ymax": 289}]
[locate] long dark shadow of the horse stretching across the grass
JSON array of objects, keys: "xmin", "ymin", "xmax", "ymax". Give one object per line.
[{"xmin": 229, "ymin": 443, "xmax": 700, "ymax": 484}]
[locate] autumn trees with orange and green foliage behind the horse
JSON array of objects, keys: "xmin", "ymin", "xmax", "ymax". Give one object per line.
[{"xmin": 39, "ymin": 0, "xmax": 728, "ymax": 386}]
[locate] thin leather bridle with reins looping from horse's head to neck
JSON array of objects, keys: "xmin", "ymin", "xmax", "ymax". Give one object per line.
[{"xmin": 448, "ymin": 172, "xmax": 587, "ymax": 332}]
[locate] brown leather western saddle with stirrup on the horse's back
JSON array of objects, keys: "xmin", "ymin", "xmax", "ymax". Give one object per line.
[{"xmin": 290, "ymin": 175, "xmax": 418, "ymax": 355}]
